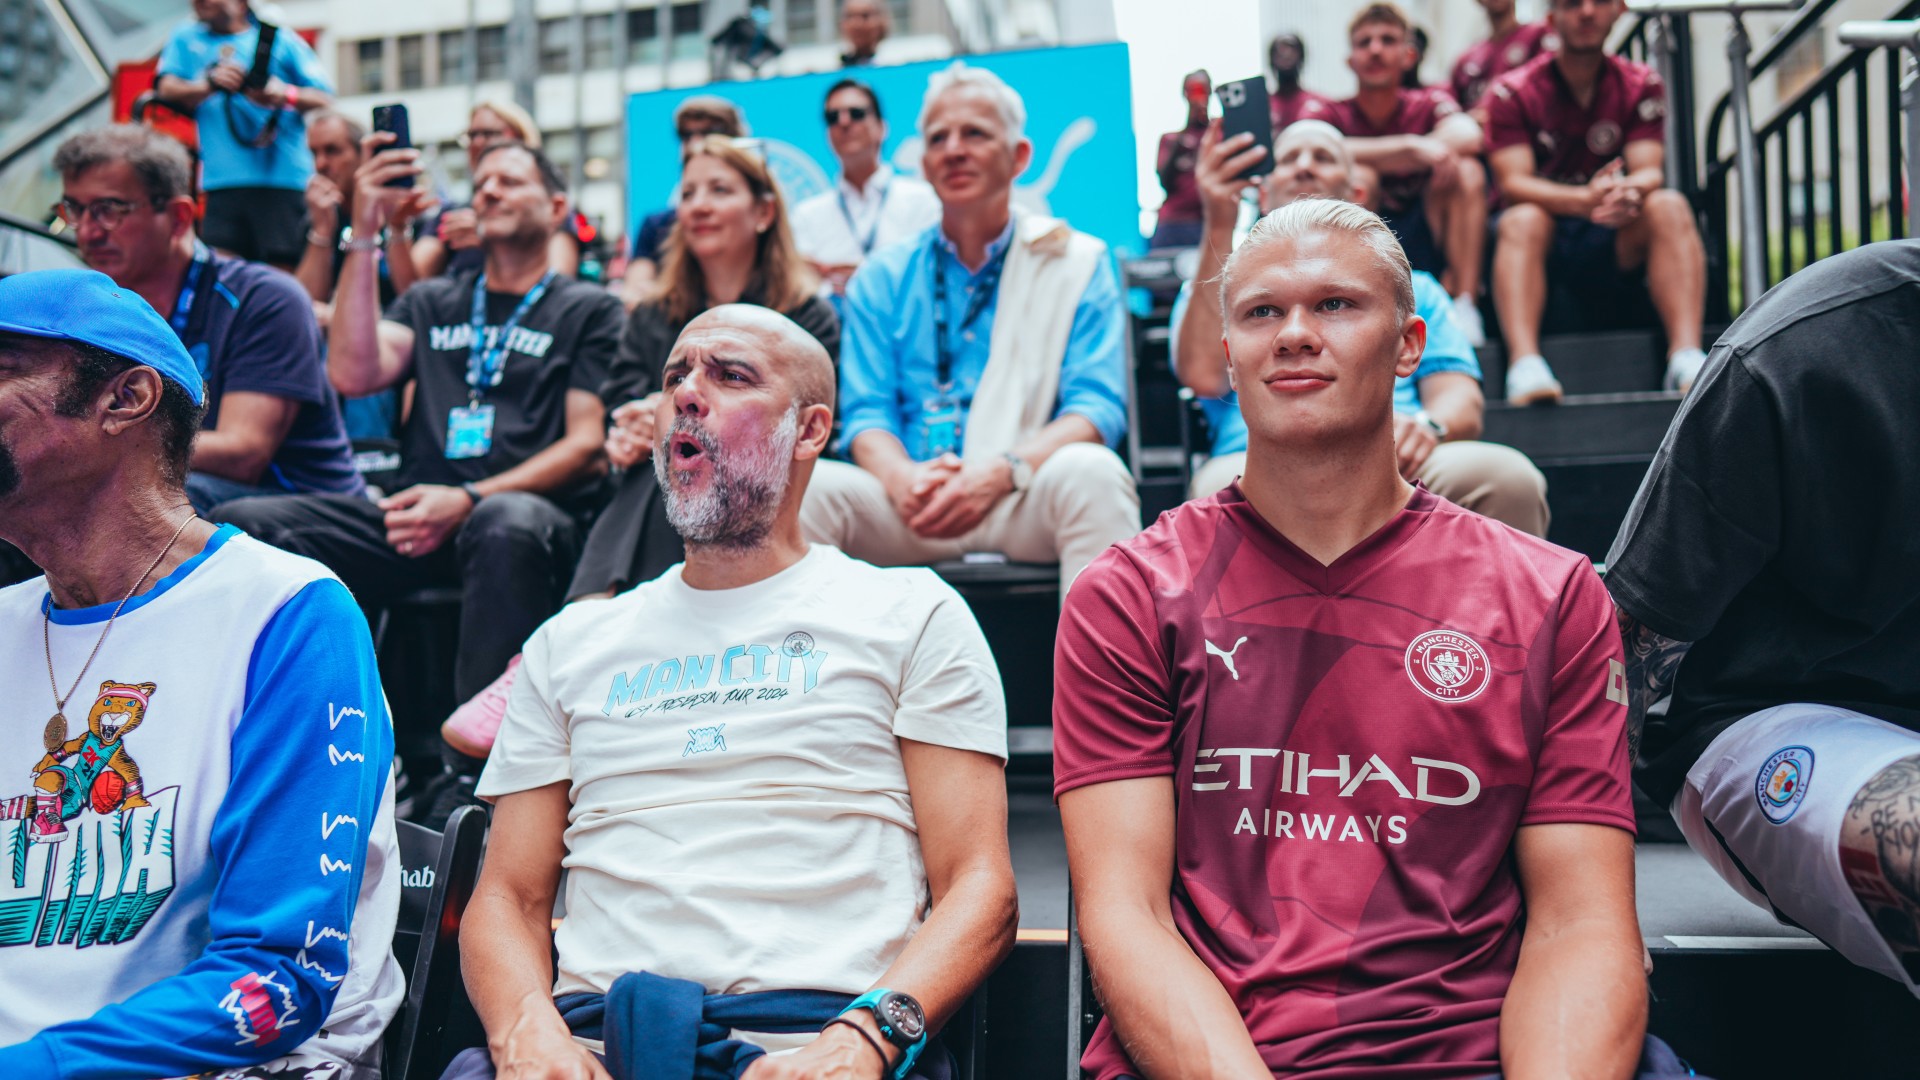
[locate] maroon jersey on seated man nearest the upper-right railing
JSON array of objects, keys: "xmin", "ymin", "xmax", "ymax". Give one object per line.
[{"xmin": 1486, "ymin": 56, "xmax": 1667, "ymax": 184}]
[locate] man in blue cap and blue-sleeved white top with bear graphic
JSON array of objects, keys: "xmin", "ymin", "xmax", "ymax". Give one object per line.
[{"xmin": 0, "ymin": 271, "xmax": 407, "ymax": 1080}]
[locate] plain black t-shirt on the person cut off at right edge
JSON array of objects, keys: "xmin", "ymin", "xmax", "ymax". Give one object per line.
[{"xmin": 1607, "ymin": 240, "xmax": 1920, "ymax": 803}]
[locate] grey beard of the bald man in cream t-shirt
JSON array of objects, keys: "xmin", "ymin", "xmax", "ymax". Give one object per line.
[{"xmin": 653, "ymin": 405, "xmax": 801, "ymax": 552}]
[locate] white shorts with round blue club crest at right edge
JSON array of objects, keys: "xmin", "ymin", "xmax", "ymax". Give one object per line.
[{"xmin": 1672, "ymin": 705, "xmax": 1920, "ymax": 995}]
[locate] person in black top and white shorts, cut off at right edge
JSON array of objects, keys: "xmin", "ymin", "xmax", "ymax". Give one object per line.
[{"xmin": 1607, "ymin": 240, "xmax": 1920, "ymax": 994}]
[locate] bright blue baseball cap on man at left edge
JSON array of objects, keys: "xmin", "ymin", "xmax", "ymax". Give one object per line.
[{"xmin": 0, "ymin": 269, "xmax": 207, "ymax": 405}]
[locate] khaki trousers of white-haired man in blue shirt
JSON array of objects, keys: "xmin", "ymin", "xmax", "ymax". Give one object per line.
[{"xmin": 801, "ymin": 442, "xmax": 1140, "ymax": 598}]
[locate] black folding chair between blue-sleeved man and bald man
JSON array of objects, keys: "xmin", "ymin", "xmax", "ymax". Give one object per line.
[{"xmin": 384, "ymin": 807, "xmax": 486, "ymax": 1080}]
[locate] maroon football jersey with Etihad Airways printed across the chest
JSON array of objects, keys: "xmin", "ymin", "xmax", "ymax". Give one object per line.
[{"xmin": 1054, "ymin": 484, "xmax": 1634, "ymax": 1080}]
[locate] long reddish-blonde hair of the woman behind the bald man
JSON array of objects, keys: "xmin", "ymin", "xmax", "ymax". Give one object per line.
[{"xmin": 653, "ymin": 135, "xmax": 820, "ymax": 323}]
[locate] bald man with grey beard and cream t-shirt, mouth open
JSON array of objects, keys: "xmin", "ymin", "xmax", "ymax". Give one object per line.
[{"xmin": 447, "ymin": 306, "xmax": 1018, "ymax": 1080}]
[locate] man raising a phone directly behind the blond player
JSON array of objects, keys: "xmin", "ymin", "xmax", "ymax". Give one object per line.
[{"xmin": 1173, "ymin": 119, "xmax": 1548, "ymax": 536}]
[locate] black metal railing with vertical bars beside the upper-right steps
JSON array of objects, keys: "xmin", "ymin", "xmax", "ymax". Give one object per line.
[{"xmin": 1701, "ymin": 0, "xmax": 1920, "ymax": 313}]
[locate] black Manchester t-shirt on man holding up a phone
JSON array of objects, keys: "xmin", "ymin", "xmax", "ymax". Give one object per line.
[{"xmin": 384, "ymin": 273, "xmax": 626, "ymax": 484}]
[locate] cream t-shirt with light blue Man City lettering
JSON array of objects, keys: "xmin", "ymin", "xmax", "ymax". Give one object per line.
[{"xmin": 478, "ymin": 546, "xmax": 1006, "ymax": 994}]
